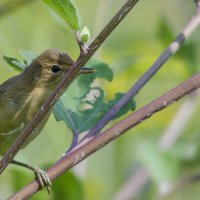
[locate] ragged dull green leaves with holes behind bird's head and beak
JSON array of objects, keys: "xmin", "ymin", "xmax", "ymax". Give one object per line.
[{"xmin": 4, "ymin": 50, "xmax": 135, "ymax": 133}]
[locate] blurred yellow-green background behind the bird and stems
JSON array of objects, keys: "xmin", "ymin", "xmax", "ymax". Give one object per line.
[{"xmin": 0, "ymin": 0, "xmax": 200, "ymax": 200}]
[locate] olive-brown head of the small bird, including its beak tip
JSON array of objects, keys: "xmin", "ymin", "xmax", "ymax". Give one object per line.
[{"xmin": 24, "ymin": 49, "xmax": 95, "ymax": 89}]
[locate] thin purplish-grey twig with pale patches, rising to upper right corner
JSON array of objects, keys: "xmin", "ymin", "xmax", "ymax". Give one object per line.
[{"xmin": 80, "ymin": 1, "xmax": 200, "ymax": 142}]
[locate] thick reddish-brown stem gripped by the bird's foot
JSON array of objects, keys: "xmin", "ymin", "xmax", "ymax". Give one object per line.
[{"xmin": 9, "ymin": 73, "xmax": 200, "ymax": 200}]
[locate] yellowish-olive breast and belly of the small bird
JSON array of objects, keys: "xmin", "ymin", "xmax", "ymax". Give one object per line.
[{"xmin": 0, "ymin": 88, "xmax": 51, "ymax": 155}]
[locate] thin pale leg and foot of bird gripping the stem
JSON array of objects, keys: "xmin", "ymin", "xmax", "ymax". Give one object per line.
[{"xmin": 11, "ymin": 160, "xmax": 51, "ymax": 193}]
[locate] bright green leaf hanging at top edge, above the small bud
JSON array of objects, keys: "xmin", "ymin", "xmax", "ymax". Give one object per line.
[{"xmin": 42, "ymin": 0, "xmax": 80, "ymax": 31}]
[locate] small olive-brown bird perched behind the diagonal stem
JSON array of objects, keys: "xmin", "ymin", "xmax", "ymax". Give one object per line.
[{"xmin": 0, "ymin": 49, "xmax": 94, "ymax": 191}]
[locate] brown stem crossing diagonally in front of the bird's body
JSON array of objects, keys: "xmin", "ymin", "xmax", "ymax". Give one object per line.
[{"xmin": 0, "ymin": 0, "xmax": 139, "ymax": 173}]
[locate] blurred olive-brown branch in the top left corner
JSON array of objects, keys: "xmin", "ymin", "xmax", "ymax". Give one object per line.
[{"xmin": 0, "ymin": 0, "xmax": 33, "ymax": 17}]
